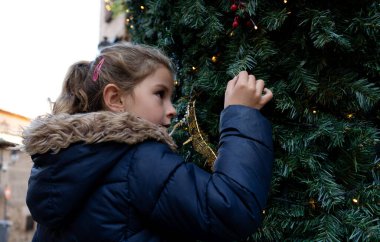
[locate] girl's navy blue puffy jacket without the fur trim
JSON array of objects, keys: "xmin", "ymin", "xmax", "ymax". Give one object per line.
[{"xmin": 27, "ymin": 106, "xmax": 273, "ymax": 242}]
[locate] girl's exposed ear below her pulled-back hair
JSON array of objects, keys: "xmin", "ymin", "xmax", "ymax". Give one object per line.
[{"xmin": 103, "ymin": 84, "xmax": 124, "ymax": 112}]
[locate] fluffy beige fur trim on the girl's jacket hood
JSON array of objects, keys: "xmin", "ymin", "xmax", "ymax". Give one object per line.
[{"xmin": 22, "ymin": 111, "xmax": 176, "ymax": 155}]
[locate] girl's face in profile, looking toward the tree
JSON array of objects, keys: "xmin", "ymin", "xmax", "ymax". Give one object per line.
[{"xmin": 123, "ymin": 67, "xmax": 176, "ymax": 127}]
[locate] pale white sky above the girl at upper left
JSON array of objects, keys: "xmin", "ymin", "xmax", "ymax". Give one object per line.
[{"xmin": 0, "ymin": 0, "xmax": 101, "ymax": 119}]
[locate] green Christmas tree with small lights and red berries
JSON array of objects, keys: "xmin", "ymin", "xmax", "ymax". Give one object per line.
[{"xmin": 108, "ymin": 0, "xmax": 380, "ymax": 241}]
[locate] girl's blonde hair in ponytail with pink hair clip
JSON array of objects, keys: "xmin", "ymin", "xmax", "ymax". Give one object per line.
[{"xmin": 53, "ymin": 43, "xmax": 175, "ymax": 114}]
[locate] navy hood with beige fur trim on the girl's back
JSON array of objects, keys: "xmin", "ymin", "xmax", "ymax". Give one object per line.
[{"xmin": 23, "ymin": 111, "xmax": 175, "ymax": 228}]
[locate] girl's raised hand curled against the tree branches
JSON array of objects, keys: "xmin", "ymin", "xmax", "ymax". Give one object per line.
[{"xmin": 224, "ymin": 71, "xmax": 273, "ymax": 110}]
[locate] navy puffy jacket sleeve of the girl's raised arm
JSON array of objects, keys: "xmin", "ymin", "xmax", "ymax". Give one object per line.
[{"xmin": 130, "ymin": 105, "xmax": 273, "ymax": 241}]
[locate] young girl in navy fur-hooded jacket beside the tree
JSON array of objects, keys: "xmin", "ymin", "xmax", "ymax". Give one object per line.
[{"xmin": 23, "ymin": 44, "xmax": 273, "ymax": 242}]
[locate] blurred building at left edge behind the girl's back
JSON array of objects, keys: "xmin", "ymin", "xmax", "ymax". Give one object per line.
[{"xmin": 0, "ymin": 109, "xmax": 35, "ymax": 242}]
